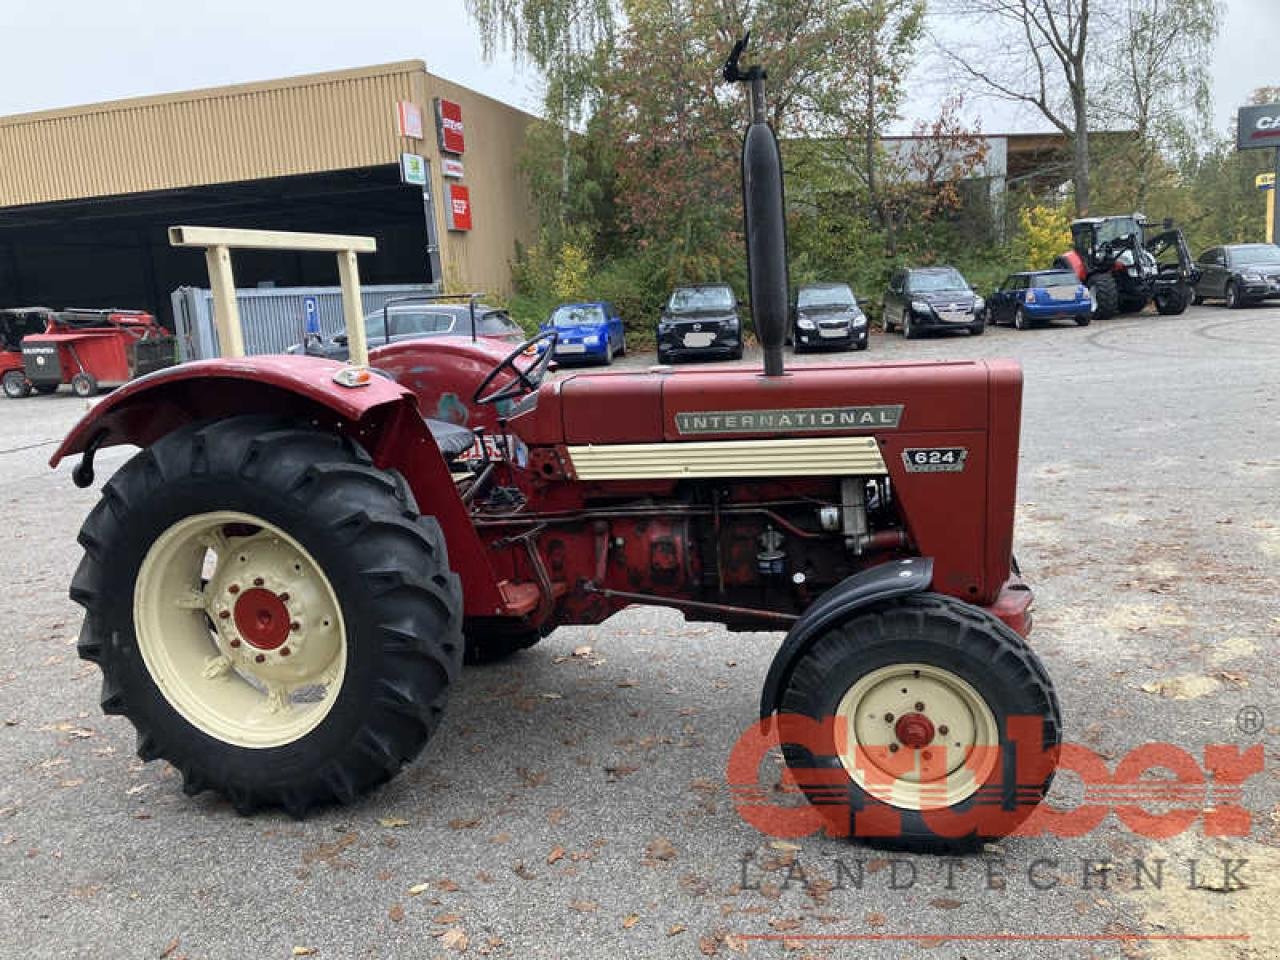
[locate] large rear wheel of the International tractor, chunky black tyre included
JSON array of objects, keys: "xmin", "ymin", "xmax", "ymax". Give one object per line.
[{"xmin": 72, "ymin": 416, "xmax": 463, "ymax": 817}]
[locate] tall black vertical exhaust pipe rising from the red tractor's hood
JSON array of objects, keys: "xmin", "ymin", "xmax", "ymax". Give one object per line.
[{"xmin": 723, "ymin": 31, "xmax": 790, "ymax": 376}]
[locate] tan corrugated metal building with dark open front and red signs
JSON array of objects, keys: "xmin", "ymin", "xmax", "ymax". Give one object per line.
[{"xmin": 0, "ymin": 60, "xmax": 535, "ymax": 319}]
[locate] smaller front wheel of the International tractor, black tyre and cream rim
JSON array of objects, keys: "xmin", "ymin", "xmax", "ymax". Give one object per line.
[{"xmin": 778, "ymin": 594, "xmax": 1061, "ymax": 851}]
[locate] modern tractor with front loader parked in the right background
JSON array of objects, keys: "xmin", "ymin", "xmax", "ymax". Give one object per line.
[{"xmin": 1053, "ymin": 214, "xmax": 1199, "ymax": 320}]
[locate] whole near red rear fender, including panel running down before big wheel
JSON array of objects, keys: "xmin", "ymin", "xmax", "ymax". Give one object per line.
[{"xmin": 49, "ymin": 356, "xmax": 502, "ymax": 616}]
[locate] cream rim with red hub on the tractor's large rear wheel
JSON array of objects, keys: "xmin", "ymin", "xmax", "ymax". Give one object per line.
[{"xmin": 133, "ymin": 511, "xmax": 347, "ymax": 748}]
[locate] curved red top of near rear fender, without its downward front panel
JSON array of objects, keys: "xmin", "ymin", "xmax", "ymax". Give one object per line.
[{"xmin": 49, "ymin": 355, "xmax": 413, "ymax": 467}]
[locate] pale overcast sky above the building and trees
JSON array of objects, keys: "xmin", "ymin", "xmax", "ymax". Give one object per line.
[{"xmin": 0, "ymin": 0, "xmax": 1280, "ymax": 138}]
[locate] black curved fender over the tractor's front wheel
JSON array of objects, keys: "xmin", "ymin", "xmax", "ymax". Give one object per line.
[{"xmin": 760, "ymin": 557, "xmax": 933, "ymax": 718}]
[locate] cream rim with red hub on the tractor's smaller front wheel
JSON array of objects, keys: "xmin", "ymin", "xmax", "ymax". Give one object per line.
[{"xmin": 836, "ymin": 663, "xmax": 1000, "ymax": 810}]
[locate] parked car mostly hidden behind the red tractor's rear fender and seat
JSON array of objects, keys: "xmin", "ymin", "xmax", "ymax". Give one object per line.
[{"xmin": 285, "ymin": 300, "xmax": 525, "ymax": 360}]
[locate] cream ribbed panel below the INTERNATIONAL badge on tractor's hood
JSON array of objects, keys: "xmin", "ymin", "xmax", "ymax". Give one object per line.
[{"xmin": 568, "ymin": 436, "xmax": 888, "ymax": 480}]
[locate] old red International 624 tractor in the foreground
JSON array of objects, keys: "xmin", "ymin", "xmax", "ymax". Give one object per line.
[{"xmin": 51, "ymin": 35, "xmax": 1060, "ymax": 849}]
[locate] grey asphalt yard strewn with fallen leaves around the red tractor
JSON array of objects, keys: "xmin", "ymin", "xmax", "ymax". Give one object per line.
[{"xmin": 0, "ymin": 306, "xmax": 1280, "ymax": 960}]
